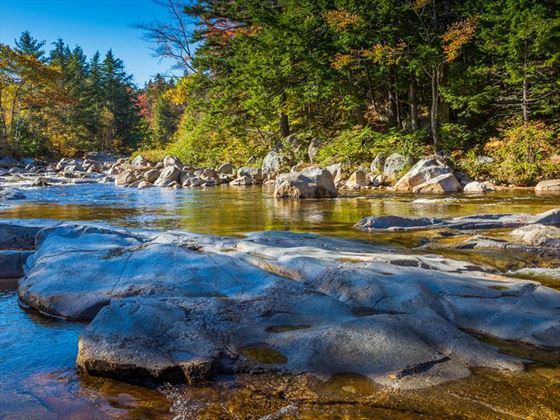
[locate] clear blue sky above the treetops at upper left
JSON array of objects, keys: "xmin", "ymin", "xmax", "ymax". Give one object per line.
[{"xmin": 0, "ymin": 0, "xmax": 183, "ymax": 86}]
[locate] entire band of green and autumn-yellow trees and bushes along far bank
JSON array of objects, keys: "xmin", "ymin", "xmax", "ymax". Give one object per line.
[{"xmin": 0, "ymin": 0, "xmax": 560, "ymax": 185}]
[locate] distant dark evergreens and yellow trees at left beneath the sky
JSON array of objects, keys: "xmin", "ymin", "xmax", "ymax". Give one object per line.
[{"xmin": 0, "ymin": 31, "xmax": 177, "ymax": 157}]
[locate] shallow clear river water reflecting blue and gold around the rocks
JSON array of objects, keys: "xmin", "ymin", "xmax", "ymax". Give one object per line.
[{"xmin": 0, "ymin": 184, "xmax": 560, "ymax": 419}]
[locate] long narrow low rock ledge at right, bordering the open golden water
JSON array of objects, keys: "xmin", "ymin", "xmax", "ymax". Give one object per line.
[{"xmin": 354, "ymin": 208, "xmax": 560, "ymax": 232}]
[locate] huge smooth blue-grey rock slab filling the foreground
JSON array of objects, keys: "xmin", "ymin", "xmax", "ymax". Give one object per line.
[{"xmin": 14, "ymin": 224, "xmax": 560, "ymax": 389}]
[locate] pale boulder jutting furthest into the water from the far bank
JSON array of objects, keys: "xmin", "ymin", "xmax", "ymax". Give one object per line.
[{"xmin": 274, "ymin": 168, "xmax": 338, "ymax": 199}]
